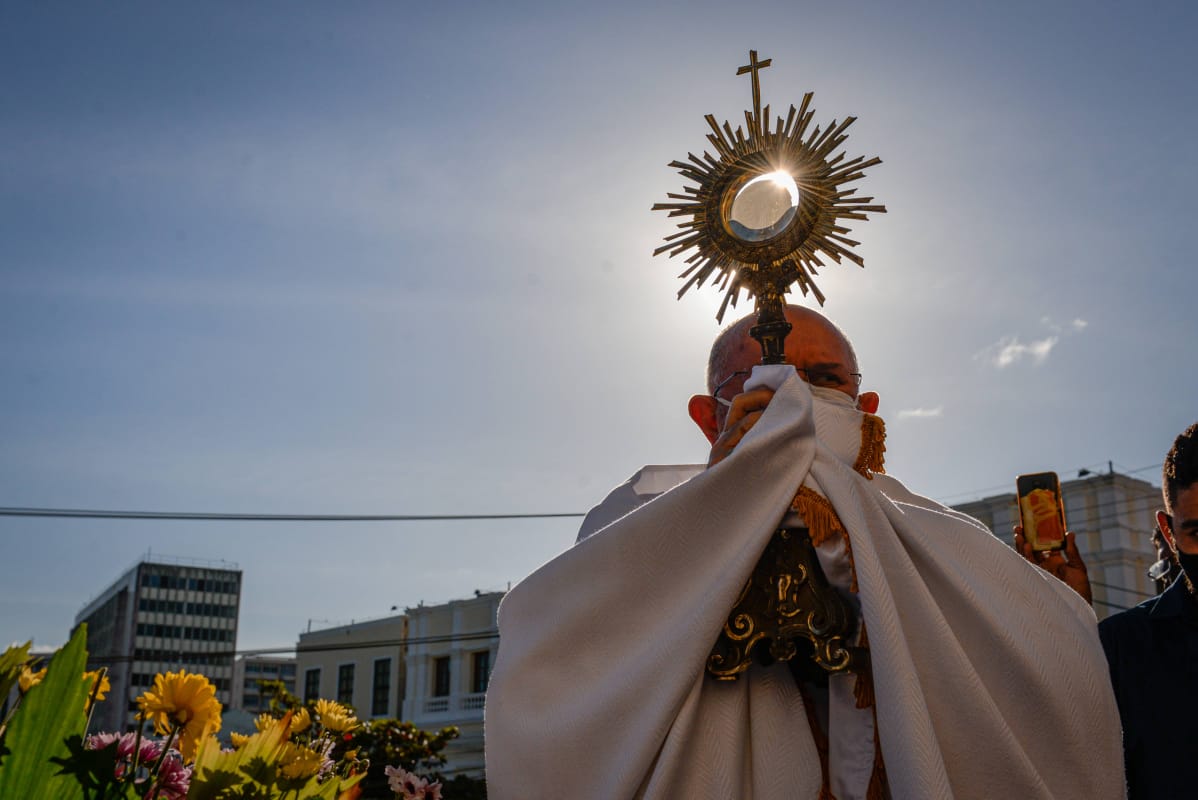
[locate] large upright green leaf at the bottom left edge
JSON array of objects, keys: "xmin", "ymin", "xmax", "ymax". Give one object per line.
[{"xmin": 0, "ymin": 625, "xmax": 87, "ymax": 800}]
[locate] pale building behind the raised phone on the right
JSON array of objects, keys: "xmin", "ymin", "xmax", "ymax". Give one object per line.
[{"xmin": 954, "ymin": 471, "xmax": 1162, "ymax": 619}]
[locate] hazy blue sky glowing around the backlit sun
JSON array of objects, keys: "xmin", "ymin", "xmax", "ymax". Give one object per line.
[{"xmin": 0, "ymin": 2, "xmax": 1198, "ymax": 648}]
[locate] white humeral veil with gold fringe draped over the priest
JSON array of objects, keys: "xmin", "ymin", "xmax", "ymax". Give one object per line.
[{"xmin": 485, "ymin": 368, "xmax": 1125, "ymax": 800}]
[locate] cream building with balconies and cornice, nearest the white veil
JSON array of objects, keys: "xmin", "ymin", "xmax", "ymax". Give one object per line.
[{"xmin": 403, "ymin": 592, "xmax": 504, "ymax": 776}]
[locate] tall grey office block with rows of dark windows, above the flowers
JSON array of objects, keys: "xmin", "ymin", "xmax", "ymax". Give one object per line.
[{"xmin": 75, "ymin": 556, "xmax": 241, "ymax": 731}]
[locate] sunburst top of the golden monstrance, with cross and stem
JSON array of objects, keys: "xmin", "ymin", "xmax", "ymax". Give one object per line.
[{"xmin": 653, "ymin": 50, "xmax": 885, "ymax": 364}]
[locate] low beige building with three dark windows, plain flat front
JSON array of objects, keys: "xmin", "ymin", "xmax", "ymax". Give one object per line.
[{"xmin": 296, "ymin": 614, "xmax": 407, "ymax": 720}]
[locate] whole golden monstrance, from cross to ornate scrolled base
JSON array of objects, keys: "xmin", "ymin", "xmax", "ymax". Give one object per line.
[{"xmin": 653, "ymin": 50, "xmax": 885, "ymax": 680}]
